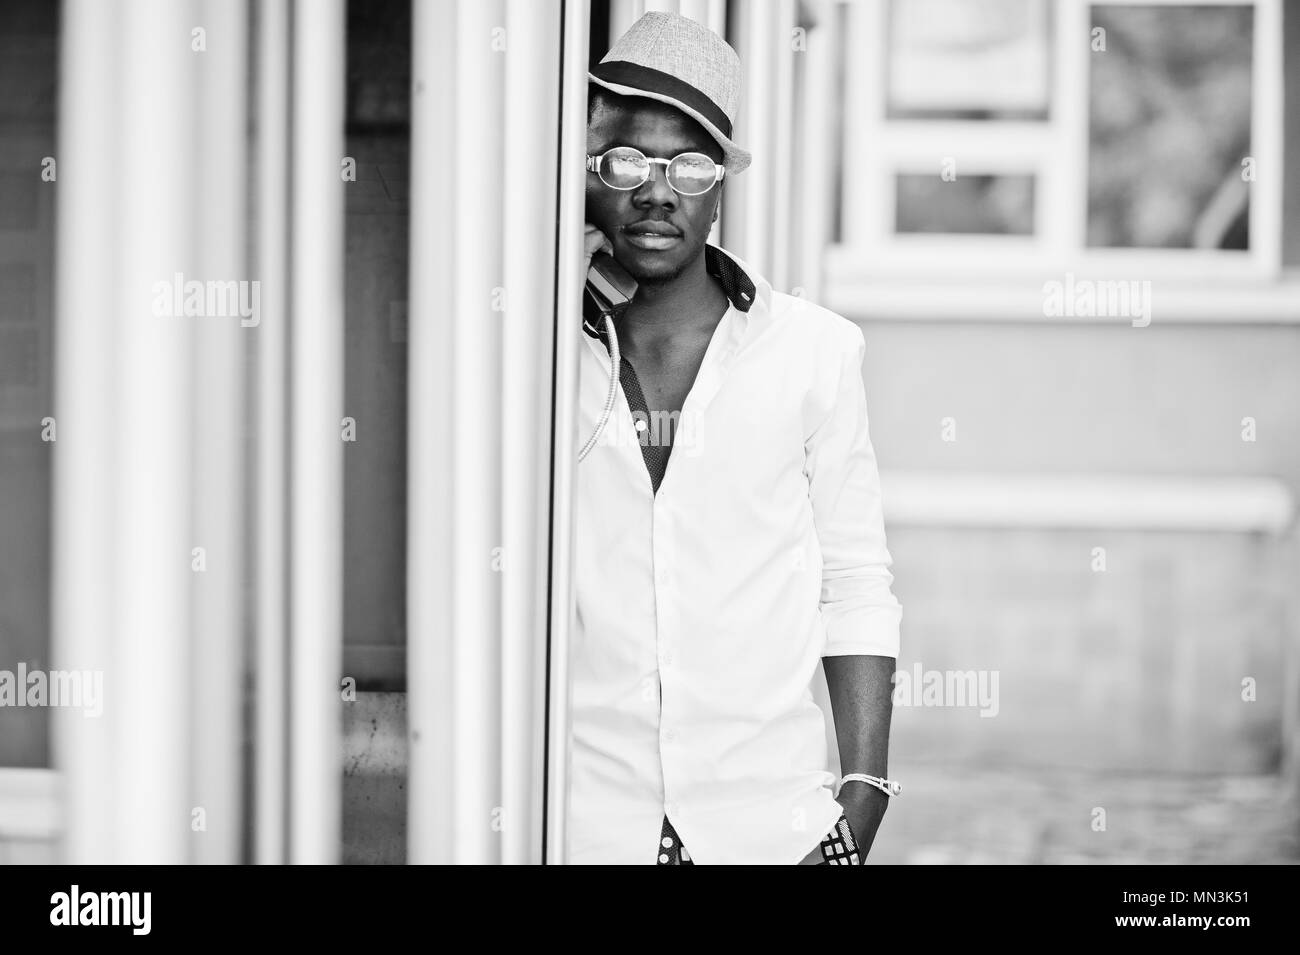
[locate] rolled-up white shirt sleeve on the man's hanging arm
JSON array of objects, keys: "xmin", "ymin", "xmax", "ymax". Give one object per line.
[{"xmin": 806, "ymin": 320, "xmax": 902, "ymax": 659}]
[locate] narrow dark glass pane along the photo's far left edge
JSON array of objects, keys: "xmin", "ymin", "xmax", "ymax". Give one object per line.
[{"xmin": 0, "ymin": 0, "xmax": 56, "ymax": 769}]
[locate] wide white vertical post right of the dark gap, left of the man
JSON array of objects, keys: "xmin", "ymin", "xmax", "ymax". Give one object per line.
[{"xmin": 408, "ymin": 1, "xmax": 509, "ymax": 863}]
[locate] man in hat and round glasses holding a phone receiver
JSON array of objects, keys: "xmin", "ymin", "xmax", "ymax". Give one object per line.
[{"xmin": 569, "ymin": 13, "xmax": 902, "ymax": 864}]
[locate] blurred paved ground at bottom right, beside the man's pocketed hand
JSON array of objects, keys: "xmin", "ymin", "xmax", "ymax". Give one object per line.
[{"xmin": 871, "ymin": 765, "xmax": 1300, "ymax": 865}]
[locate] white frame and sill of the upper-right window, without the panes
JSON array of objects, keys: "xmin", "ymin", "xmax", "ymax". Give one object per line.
[{"xmin": 824, "ymin": 0, "xmax": 1300, "ymax": 321}]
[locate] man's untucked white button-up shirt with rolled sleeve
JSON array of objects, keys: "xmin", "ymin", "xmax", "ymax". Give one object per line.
[{"xmin": 568, "ymin": 247, "xmax": 902, "ymax": 865}]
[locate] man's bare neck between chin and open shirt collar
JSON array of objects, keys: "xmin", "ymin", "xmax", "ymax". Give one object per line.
[{"xmin": 619, "ymin": 255, "xmax": 728, "ymax": 353}]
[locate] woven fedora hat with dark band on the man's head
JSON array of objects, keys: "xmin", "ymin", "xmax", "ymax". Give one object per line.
[{"xmin": 588, "ymin": 12, "xmax": 750, "ymax": 175}]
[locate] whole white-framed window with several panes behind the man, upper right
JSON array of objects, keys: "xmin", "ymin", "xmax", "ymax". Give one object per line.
[{"xmin": 824, "ymin": 0, "xmax": 1294, "ymax": 317}]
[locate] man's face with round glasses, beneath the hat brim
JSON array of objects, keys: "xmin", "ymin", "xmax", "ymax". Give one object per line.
[{"xmin": 586, "ymin": 99, "xmax": 723, "ymax": 282}]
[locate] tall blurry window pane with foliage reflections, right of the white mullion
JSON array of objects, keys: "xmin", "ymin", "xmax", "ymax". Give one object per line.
[{"xmin": 1088, "ymin": 5, "xmax": 1253, "ymax": 248}]
